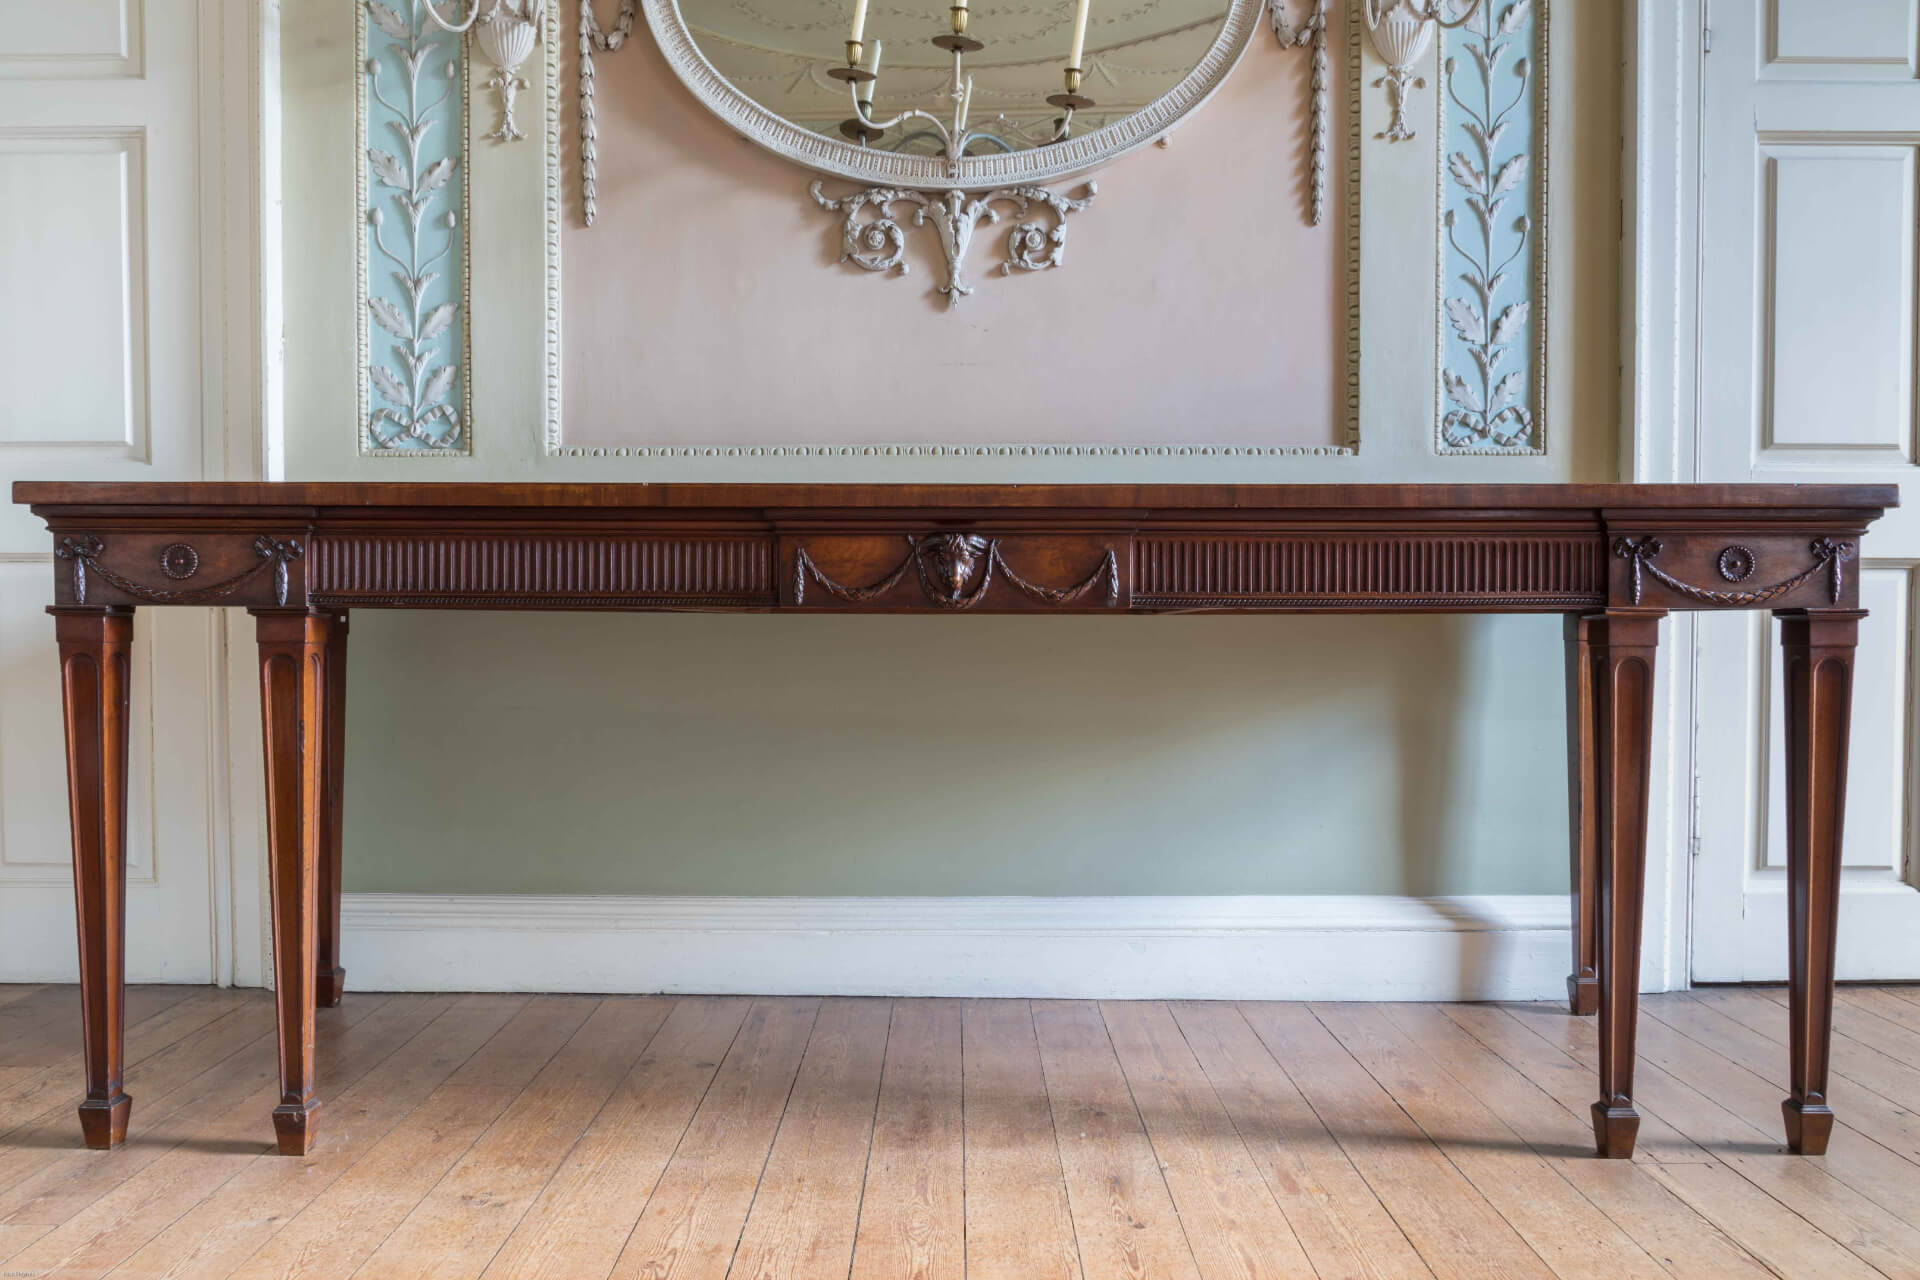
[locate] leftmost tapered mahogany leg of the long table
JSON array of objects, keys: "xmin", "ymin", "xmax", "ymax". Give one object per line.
[{"xmin": 48, "ymin": 608, "xmax": 132, "ymax": 1150}]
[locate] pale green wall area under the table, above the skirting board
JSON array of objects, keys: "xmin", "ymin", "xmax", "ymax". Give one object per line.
[{"xmin": 346, "ymin": 610, "xmax": 1567, "ymax": 894}]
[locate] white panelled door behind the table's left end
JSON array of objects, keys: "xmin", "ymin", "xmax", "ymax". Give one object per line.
[{"xmin": 0, "ymin": 0, "xmax": 225, "ymax": 983}]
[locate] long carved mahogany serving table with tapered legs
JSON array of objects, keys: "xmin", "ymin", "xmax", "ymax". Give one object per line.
[{"xmin": 13, "ymin": 484, "xmax": 1897, "ymax": 1157}]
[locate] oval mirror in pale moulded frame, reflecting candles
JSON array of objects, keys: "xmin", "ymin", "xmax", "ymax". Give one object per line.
[{"xmin": 645, "ymin": 0, "xmax": 1261, "ymax": 190}]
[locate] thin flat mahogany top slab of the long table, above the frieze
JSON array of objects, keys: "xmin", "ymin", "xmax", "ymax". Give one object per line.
[{"xmin": 13, "ymin": 480, "xmax": 1899, "ymax": 518}]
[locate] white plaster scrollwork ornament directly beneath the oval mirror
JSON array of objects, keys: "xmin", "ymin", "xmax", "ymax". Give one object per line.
[{"xmin": 806, "ymin": 178, "xmax": 1100, "ymax": 307}]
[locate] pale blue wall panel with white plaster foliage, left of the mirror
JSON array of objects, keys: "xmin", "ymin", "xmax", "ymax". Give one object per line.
[{"xmin": 359, "ymin": 0, "xmax": 468, "ymax": 455}]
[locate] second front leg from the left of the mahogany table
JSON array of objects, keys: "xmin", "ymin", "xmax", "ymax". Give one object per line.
[{"xmin": 253, "ymin": 610, "xmax": 336, "ymax": 1155}]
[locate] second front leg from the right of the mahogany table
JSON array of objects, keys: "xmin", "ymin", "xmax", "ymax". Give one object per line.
[{"xmin": 1588, "ymin": 608, "xmax": 1663, "ymax": 1159}]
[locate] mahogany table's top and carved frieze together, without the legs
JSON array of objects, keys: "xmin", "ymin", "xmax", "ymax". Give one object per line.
[{"xmin": 13, "ymin": 482, "xmax": 1897, "ymax": 614}]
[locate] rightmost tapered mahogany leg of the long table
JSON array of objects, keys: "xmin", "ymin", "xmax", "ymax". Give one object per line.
[{"xmin": 1778, "ymin": 608, "xmax": 1866, "ymax": 1155}]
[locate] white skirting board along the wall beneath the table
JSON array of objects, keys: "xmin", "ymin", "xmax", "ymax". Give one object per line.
[{"xmin": 342, "ymin": 894, "xmax": 1571, "ymax": 1000}]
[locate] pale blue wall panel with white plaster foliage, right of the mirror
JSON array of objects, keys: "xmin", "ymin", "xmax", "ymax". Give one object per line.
[{"xmin": 1438, "ymin": 0, "xmax": 1548, "ymax": 455}]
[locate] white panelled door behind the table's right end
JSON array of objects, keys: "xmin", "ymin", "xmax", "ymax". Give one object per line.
[{"xmin": 1693, "ymin": 0, "xmax": 1920, "ymax": 983}]
